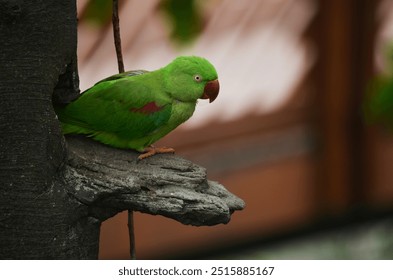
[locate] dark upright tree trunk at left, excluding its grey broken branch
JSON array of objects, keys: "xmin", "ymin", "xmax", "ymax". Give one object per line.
[{"xmin": 0, "ymin": 0, "xmax": 100, "ymax": 259}]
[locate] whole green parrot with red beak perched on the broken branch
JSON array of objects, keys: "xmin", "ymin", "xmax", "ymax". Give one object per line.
[{"xmin": 55, "ymin": 56, "xmax": 219, "ymax": 159}]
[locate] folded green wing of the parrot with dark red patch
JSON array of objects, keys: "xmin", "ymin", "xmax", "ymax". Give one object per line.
[{"xmin": 62, "ymin": 75, "xmax": 172, "ymax": 139}]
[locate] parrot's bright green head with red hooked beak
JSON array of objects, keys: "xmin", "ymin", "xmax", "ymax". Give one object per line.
[{"xmin": 165, "ymin": 56, "xmax": 220, "ymax": 102}]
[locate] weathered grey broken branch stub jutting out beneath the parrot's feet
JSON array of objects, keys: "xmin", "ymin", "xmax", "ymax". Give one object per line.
[{"xmin": 65, "ymin": 136, "xmax": 244, "ymax": 226}]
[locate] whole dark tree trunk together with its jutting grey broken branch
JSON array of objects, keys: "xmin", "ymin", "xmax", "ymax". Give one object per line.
[{"xmin": 0, "ymin": 0, "xmax": 244, "ymax": 259}]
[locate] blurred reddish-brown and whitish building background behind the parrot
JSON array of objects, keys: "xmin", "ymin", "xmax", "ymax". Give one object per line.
[{"xmin": 77, "ymin": 0, "xmax": 393, "ymax": 259}]
